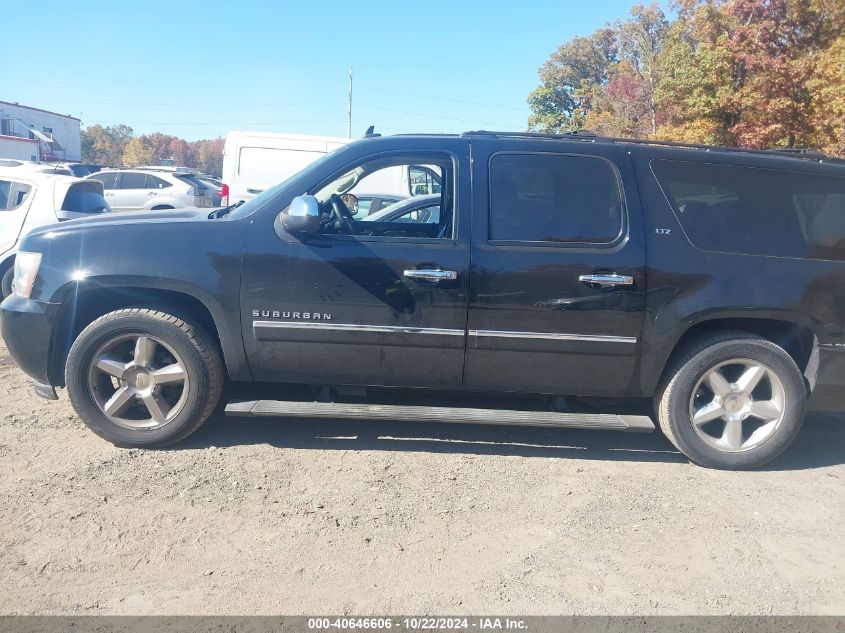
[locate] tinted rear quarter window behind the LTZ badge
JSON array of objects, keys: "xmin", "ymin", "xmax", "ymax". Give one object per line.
[{"xmin": 652, "ymin": 160, "xmax": 845, "ymax": 259}]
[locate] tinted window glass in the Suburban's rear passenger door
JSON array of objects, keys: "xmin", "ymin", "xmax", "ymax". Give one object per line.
[{"xmin": 489, "ymin": 154, "xmax": 623, "ymax": 244}]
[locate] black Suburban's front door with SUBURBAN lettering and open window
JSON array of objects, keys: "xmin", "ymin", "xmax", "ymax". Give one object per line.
[{"xmin": 241, "ymin": 139, "xmax": 470, "ymax": 389}]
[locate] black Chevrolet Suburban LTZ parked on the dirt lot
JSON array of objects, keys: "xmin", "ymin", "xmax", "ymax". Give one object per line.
[{"xmin": 2, "ymin": 132, "xmax": 845, "ymax": 469}]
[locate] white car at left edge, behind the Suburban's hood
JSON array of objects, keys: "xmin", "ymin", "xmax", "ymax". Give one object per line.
[{"xmin": 0, "ymin": 165, "xmax": 111, "ymax": 299}]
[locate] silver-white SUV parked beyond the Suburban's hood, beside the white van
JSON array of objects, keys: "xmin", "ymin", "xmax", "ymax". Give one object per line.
[{"xmin": 87, "ymin": 167, "xmax": 219, "ymax": 211}]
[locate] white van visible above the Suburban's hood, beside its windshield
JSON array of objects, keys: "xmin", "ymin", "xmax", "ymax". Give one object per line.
[{"xmin": 221, "ymin": 132, "xmax": 351, "ymax": 207}]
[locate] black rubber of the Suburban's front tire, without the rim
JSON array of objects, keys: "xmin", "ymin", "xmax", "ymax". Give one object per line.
[{"xmin": 66, "ymin": 314, "xmax": 216, "ymax": 447}]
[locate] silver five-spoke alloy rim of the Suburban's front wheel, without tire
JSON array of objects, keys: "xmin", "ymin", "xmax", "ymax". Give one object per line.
[{"xmin": 88, "ymin": 334, "xmax": 191, "ymax": 430}]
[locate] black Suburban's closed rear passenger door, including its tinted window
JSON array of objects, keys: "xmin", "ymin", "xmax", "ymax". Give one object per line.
[{"xmin": 464, "ymin": 138, "xmax": 646, "ymax": 395}]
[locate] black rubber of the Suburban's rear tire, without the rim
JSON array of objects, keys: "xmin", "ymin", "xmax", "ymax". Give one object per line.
[{"xmin": 668, "ymin": 339, "xmax": 807, "ymax": 469}]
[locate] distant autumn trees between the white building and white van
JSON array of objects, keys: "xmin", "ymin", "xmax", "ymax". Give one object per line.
[{"xmin": 81, "ymin": 124, "xmax": 223, "ymax": 176}]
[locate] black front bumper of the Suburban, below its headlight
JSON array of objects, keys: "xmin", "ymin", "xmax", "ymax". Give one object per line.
[{"xmin": 0, "ymin": 295, "xmax": 60, "ymax": 385}]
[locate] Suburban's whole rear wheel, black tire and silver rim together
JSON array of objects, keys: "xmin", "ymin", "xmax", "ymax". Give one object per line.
[{"xmin": 655, "ymin": 332, "xmax": 807, "ymax": 470}]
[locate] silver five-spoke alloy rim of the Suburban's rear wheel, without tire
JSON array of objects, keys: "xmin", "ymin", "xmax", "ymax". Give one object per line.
[{"xmin": 689, "ymin": 359, "xmax": 786, "ymax": 453}]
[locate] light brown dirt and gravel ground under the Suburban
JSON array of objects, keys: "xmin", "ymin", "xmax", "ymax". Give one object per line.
[{"xmin": 0, "ymin": 338, "xmax": 845, "ymax": 614}]
